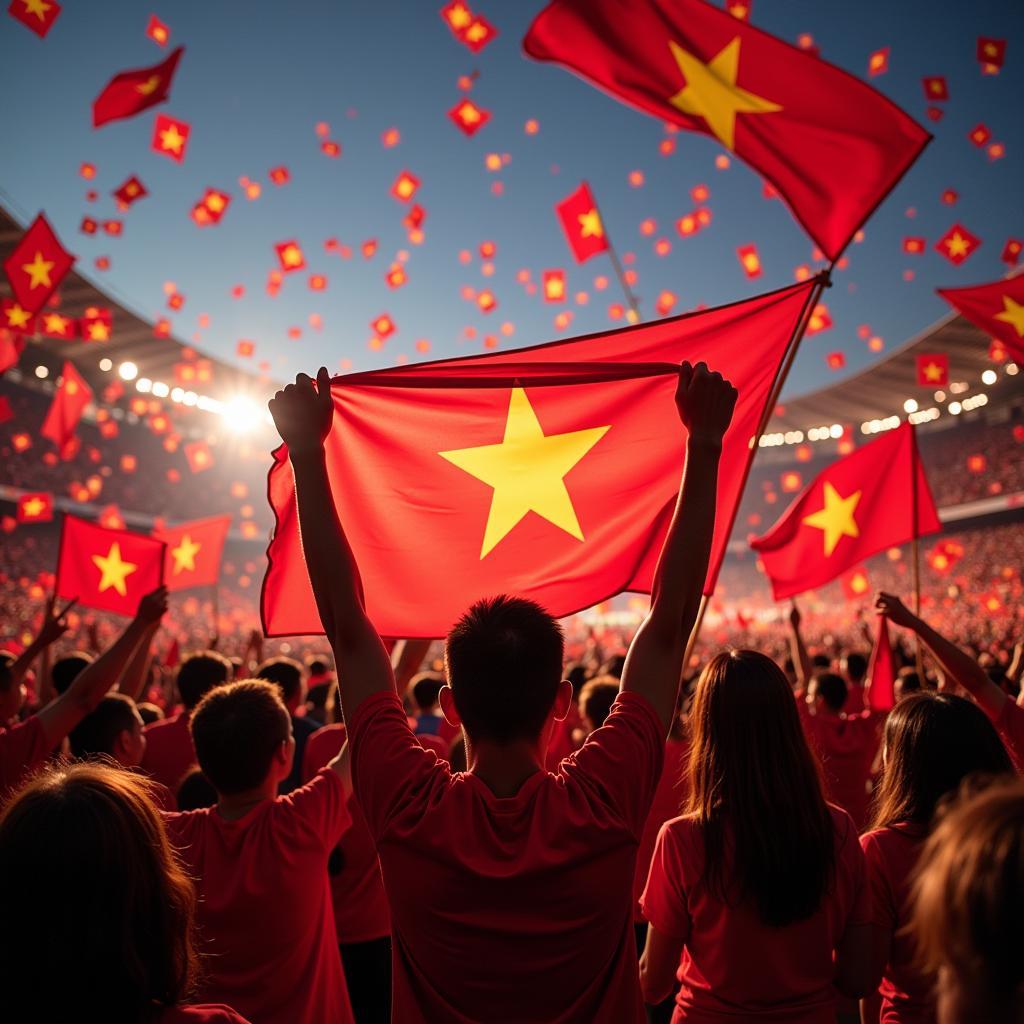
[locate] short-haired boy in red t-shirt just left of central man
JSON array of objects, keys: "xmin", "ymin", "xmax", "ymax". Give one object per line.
[{"xmin": 166, "ymin": 680, "xmax": 352, "ymax": 1024}]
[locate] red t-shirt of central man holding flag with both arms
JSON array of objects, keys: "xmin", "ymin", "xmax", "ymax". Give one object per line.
[{"xmin": 349, "ymin": 692, "xmax": 665, "ymax": 1024}]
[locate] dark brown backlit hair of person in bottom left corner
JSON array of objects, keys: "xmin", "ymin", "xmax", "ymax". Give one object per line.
[{"xmin": 0, "ymin": 762, "xmax": 199, "ymax": 1024}]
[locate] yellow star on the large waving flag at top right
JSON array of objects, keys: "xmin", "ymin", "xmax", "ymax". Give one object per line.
[{"xmin": 669, "ymin": 36, "xmax": 782, "ymax": 150}]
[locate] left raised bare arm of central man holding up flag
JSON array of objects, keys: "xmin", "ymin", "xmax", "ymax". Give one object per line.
[{"xmin": 270, "ymin": 367, "xmax": 395, "ymax": 722}]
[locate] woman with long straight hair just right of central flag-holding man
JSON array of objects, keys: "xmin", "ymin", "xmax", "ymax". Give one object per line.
[{"xmin": 640, "ymin": 650, "xmax": 869, "ymax": 1024}]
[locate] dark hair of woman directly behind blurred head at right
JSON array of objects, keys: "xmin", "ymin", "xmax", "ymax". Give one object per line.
[{"xmin": 871, "ymin": 692, "xmax": 1014, "ymax": 828}]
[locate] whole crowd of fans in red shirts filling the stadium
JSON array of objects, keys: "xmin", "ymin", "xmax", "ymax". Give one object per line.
[{"xmin": 0, "ymin": 364, "xmax": 1024, "ymax": 1024}]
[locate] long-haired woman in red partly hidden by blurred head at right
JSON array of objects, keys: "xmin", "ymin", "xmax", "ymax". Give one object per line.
[{"xmin": 860, "ymin": 692, "xmax": 1013, "ymax": 1024}]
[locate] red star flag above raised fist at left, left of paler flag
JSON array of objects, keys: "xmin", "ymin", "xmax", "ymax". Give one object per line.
[{"xmin": 55, "ymin": 515, "xmax": 164, "ymax": 615}]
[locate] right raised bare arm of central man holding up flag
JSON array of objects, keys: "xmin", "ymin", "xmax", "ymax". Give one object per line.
[{"xmin": 623, "ymin": 362, "xmax": 736, "ymax": 733}]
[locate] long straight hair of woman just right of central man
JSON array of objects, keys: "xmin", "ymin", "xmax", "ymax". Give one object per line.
[{"xmin": 685, "ymin": 650, "xmax": 836, "ymax": 928}]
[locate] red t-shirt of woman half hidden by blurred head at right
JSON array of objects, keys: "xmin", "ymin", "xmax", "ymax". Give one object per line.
[{"xmin": 860, "ymin": 821, "xmax": 936, "ymax": 1024}]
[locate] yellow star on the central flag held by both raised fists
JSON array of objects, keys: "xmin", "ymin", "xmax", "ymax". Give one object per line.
[{"xmin": 437, "ymin": 387, "xmax": 610, "ymax": 558}]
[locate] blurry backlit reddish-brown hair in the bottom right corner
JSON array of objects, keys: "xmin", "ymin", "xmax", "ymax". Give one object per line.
[{"xmin": 909, "ymin": 778, "xmax": 1024, "ymax": 1020}]
